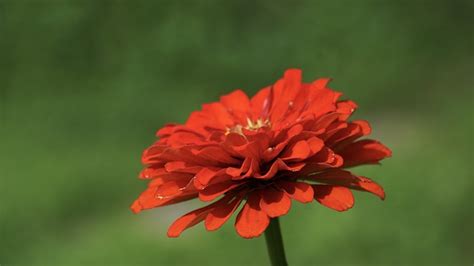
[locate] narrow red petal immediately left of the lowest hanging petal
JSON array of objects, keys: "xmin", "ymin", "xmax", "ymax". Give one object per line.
[{"xmin": 204, "ymin": 194, "xmax": 243, "ymax": 231}]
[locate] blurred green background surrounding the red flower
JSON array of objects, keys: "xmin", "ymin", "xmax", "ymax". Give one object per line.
[{"xmin": 0, "ymin": 0, "xmax": 474, "ymax": 265}]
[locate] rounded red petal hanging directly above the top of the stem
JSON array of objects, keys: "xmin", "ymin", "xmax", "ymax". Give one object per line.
[{"xmin": 260, "ymin": 187, "xmax": 291, "ymax": 218}]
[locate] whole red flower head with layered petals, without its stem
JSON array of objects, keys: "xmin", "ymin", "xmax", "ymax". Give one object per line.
[{"xmin": 131, "ymin": 69, "xmax": 391, "ymax": 238}]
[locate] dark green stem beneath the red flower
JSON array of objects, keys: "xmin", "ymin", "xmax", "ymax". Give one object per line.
[{"xmin": 265, "ymin": 218, "xmax": 288, "ymax": 266}]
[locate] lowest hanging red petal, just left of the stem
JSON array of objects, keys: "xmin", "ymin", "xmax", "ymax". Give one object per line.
[{"xmin": 235, "ymin": 192, "xmax": 270, "ymax": 238}]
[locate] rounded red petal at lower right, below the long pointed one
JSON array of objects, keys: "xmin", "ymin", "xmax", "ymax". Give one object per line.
[{"xmin": 313, "ymin": 185, "xmax": 354, "ymax": 211}]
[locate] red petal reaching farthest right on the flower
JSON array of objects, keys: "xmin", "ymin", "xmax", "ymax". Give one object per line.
[{"xmin": 339, "ymin": 139, "xmax": 392, "ymax": 167}]
